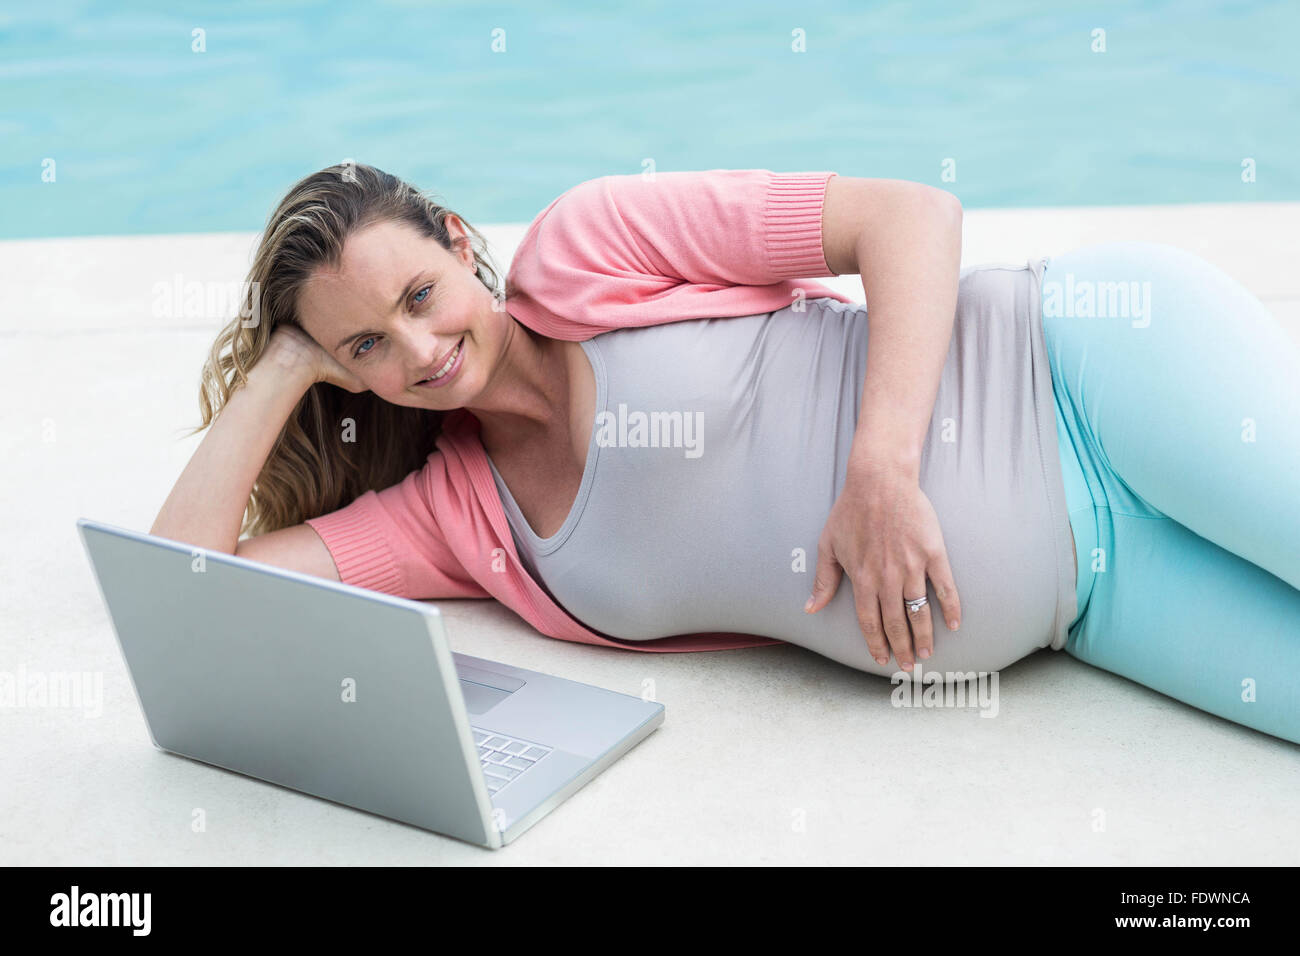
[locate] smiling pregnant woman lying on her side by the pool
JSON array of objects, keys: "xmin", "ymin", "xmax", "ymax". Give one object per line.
[{"xmin": 152, "ymin": 164, "xmax": 1300, "ymax": 743}]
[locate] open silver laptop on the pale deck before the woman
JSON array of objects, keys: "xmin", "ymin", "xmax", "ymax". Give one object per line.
[{"xmin": 77, "ymin": 518, "xmax": 664, "ymax": 849}]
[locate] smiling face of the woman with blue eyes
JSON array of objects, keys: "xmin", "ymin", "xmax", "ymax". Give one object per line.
[{"xmin": 298, "ymin": 216, "xmax": 511, "ymax": 411}]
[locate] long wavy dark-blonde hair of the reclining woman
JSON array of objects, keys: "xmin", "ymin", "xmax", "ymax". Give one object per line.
[{"xmin": 190, "ymin": 163, "xmax": 504, "ymax": 535}]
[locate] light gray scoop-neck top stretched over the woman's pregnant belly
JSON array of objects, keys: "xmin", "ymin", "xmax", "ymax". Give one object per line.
[{"xmin": 489, "ymin": 259, "xmax": 1075, "ymax": 672}]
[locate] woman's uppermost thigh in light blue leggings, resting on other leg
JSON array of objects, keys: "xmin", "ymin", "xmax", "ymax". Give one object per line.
[{"xmin": 1043, "ymin": 242, "xmax": 1300, "ymax": 588}]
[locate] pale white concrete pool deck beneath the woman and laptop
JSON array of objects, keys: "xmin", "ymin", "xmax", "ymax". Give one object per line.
[{"xmin": 0, "ymin": 203, "xmax": 1300, "ymax": 865}]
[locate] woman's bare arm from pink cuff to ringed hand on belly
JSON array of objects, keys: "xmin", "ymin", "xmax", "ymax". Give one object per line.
[{"xmin": 805, "ymin": 176, "xmax": 962, "ymax": 670}]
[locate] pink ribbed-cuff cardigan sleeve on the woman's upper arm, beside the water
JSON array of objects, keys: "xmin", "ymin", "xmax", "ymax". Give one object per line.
[{"xmin": 496, "ymin": 169, "xmax": 852, "ymax": 341}]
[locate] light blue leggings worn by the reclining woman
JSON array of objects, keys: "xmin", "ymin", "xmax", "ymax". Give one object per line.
[{"xmin": 1043, "ymin": 242, "xmax": 1300, "ymax": 743}]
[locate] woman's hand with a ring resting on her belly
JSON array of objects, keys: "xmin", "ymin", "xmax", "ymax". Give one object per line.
[{"xmin": 803, "ymin": 466, "xmax": 961, "ymax": 670}]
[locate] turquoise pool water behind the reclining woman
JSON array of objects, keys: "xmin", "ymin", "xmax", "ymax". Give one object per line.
[{"xmin": 0, "ymin": 0, "xmax": 1300, "ymax": 238}]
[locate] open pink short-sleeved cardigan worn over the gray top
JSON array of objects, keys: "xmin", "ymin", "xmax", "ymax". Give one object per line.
[{"xmin": 307, "ymin": 169, "xmax": 852, "ymax": 650}]
